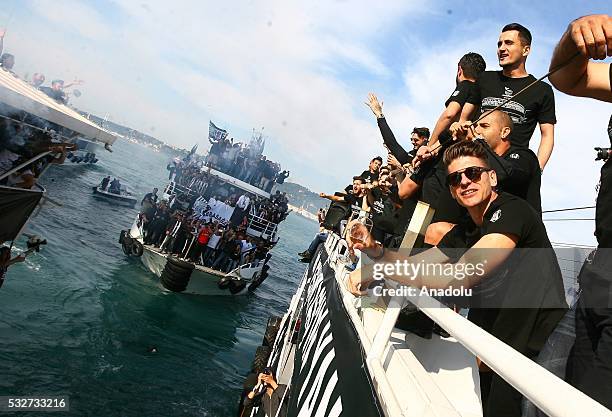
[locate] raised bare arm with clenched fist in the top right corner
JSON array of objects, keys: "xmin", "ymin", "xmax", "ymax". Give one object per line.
[{"xmin": 548, "ymin": 15, "xmax": 612, "ymax": 102}]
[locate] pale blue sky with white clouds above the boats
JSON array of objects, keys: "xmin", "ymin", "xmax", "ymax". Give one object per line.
[{"xmin": 0, "ymin": 0, "xmax": 611, "ymax": 244}]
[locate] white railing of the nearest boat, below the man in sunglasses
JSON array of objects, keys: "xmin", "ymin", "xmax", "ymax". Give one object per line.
[{"xmin": 325, "ymin": 202, "xmax": 612, "ymax": 417}]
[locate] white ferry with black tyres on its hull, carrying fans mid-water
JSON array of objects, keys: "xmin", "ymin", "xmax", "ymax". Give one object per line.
[{"xmin": 119, "ymin": 127, "xmax": 290, "ymax": 296}]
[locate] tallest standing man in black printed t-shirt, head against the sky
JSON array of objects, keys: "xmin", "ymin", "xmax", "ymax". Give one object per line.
[{"xmin": 460, "ymin": 23, "xmax": 557, "ymax": 169}]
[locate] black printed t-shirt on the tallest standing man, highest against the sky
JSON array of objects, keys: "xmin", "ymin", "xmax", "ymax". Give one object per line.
[{"xmin": 467, "ymin": 71, "xmax": 557, "ymax": 147}]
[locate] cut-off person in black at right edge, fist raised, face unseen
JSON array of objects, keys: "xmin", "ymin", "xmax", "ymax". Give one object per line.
[{"xmin": 550, "ymin": 15, "xmax": 612, "ymax": 409}]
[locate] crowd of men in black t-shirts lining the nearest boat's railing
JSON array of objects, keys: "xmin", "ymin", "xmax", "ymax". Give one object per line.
[{"xmin": 299, "ymin": 16, "xmax": 612, "ymax": 416}]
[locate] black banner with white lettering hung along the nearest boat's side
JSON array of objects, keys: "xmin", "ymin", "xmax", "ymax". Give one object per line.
[{"xmin": 286, "ymin": 245, "xmax": 384, "ymax": 417}]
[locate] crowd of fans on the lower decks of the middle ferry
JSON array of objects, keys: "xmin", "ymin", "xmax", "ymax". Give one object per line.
[{"xmin": 140, "ymin": 154, "xmax": 289, "ymax": 272}]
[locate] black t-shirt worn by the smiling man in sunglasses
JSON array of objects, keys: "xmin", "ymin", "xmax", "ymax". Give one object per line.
[{"xmin": 438, "ymin": 193, "xmax": 567, "ymax": 356}]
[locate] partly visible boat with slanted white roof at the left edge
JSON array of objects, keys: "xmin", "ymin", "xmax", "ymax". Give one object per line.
[{"xmin": 0, "ymin": 69, "xmax": 117, "ymax": 242}]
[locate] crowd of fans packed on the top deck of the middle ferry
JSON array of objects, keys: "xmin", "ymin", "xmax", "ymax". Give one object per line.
[{"xmin": 206, "ymin": 138, "xmax": 289, "ymax": 192}]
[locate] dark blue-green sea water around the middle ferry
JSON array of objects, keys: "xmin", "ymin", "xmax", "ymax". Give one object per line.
[{"xmin": 0, "ymin": 141, "xmax": 317, "ymax": 417}]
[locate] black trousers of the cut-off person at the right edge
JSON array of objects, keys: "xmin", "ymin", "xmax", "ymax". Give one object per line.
[{"xmin": 566, "ymin": 248, "xmax": 612, "ymax": 410}]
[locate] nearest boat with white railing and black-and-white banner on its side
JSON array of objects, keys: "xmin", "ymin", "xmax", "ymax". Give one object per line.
[{"xmin": 238, "ymin": 203, "xmax": 612, "ymax": 417}]
